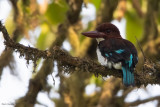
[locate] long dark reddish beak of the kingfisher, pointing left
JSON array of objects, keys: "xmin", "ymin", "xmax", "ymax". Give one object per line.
[{"xmin": 82, "ymin": 31, "xmax": 105, "ymax": 38}]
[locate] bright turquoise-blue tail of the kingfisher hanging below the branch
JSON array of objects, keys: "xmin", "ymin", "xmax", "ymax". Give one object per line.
[{"xmin": 122, "ymin": 66, "xmax": 134, "ymax": 86}]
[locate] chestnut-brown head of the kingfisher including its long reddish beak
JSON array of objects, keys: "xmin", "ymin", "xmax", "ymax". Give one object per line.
[{"xmin": 82, "ymin": 23, "xmax": 122, "ymax": 42}]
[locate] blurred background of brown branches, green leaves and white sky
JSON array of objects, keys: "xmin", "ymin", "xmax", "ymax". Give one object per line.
[{"xmin": 0, "ymin": 0, "xmax": 160, "ymax": 107}]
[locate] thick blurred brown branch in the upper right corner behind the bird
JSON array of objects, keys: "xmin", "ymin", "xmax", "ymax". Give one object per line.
[{"xmin": 140, "ymin": 0, "xmax": 160, "ymax": 45}]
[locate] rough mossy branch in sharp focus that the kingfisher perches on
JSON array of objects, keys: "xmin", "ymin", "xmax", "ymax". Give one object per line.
[{"xmin": 0, "ymin": 22, "xmax": 160, "ymax": 86}]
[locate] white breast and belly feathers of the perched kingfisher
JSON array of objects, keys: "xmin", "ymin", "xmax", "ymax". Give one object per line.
[{"xmin": 97, "ymin": 48, "xmax": 122, "ymax": 69}]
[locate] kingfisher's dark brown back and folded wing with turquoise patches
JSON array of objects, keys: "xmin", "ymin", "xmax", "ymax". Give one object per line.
[{"xmin": 98, "ymin": 39, "xmax": 137, "ymax": 65}]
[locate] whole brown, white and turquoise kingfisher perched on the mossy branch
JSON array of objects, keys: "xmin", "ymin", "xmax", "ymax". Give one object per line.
[{"xmin": 82, "ymin": 23, "xmax": 138, "ymax": 86}]
